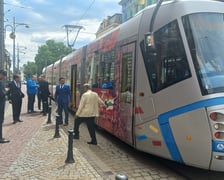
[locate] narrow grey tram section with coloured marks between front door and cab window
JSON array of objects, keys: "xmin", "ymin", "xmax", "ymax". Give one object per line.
[{"xmin": 134, "ymin": 3, "xmax": 172, "ymax": 159}]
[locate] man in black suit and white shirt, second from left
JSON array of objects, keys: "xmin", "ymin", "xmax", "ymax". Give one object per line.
[{"xmin": 8, "ymin": 75, "xmax": 24, "ymax": 124}]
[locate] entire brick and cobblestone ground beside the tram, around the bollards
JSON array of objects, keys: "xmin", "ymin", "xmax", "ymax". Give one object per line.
[{"xmin": 0, "ymin": 85, "xmax": 186, "ymax": 180}]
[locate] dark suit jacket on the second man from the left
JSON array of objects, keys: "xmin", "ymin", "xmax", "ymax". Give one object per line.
[{"xmin": 8, "ymin": 81, "xmax": 24, "ymax": 101}]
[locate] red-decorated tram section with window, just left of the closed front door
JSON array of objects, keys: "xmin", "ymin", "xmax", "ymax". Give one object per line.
[{"xmin": 85, "ymin": 29, "xmax": 119, "ymax": 138}]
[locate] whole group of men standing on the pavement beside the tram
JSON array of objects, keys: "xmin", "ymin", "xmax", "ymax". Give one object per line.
[{"xmin": 0, "ymin": 70, "xmax": 105, "ymax": 145}]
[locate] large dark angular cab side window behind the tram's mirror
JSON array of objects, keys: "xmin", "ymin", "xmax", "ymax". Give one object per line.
[{"xmin": 145, "ymin": 20, "xmax": 191, "ymax": 93}]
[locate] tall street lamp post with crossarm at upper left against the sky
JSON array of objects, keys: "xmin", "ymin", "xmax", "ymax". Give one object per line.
[{"xmin": 7, "ymin": 17, "xmax": 29, "ymax": 73}]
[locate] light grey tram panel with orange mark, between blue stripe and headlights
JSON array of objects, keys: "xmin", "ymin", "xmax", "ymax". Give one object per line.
[{"xmin": 169, "ymin": 108, "xmax": 212, "ymax": 169}]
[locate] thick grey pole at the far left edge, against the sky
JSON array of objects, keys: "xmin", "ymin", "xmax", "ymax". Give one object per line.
[{"xmin": 0, "ymin": 0, "xmax": 5, "ymax": 69}]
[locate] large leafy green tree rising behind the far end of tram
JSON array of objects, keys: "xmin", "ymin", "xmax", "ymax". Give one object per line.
[{"xmin": 35, "ymin": 40, "xmax": 72, "ymax": 75}]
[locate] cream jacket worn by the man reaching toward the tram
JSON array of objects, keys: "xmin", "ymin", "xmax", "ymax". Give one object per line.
[{"xmin": 76, "ymin": 90, "xmax": 104, "ymax": 117}]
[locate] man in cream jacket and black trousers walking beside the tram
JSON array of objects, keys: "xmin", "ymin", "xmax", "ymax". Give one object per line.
[{"xmin": 74, "ymin": 83, "xmax": 105, "ymax": 145}]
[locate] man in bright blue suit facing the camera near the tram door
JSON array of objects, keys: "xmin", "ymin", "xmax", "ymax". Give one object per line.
[{"xmin": 55, "ymin": 77, "xmax": 71, "ymax": 126}]
